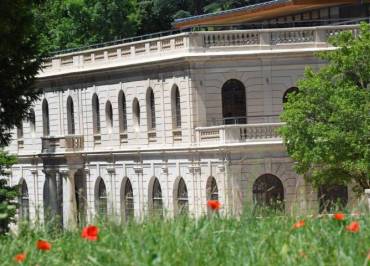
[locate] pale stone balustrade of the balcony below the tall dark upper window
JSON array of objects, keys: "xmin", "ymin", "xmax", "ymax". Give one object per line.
[{"xmin": 196, "ymin": 123, "xmax": 283, "ymax": 145}]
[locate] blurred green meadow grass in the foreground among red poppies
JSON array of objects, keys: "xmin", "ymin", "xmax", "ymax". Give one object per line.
[{"xmin": 0, "ymin": 212, "xmax": 370, "ymax": 266}]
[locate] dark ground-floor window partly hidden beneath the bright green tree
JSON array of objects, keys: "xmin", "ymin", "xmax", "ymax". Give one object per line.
[{"xmin": 318, "ymin": 185, "xmax": 348, "ymax": 213}]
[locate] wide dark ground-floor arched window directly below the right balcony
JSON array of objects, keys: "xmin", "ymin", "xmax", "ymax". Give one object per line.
[{"xmin": 253, "ymin": 174, "xmax": 284, "ymax": 210}]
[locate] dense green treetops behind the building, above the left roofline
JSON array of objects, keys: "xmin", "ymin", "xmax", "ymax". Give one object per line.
[{"xmin": 33, "ymin": 0, "xmax": 267, "ymax": 52}]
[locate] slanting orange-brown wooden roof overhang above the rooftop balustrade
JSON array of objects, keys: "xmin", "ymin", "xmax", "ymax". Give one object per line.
[{"xmin": 174, "ymin": 0, "xmax": 361, "ymax": 29}]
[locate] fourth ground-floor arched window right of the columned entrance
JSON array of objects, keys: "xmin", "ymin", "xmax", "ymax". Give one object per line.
[{"xmin": 172, "ymin": 177, "xmax": 189, "ymax": 215}]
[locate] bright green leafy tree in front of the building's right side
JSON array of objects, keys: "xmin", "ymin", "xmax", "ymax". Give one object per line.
[{"xmin": 281, "ymin": 24, "xmax": 370, "ymax": 191}]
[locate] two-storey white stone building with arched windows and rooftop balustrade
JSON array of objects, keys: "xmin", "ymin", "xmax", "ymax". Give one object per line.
[{"xmin": 2, "ymin": 1, "xmax": 369, "ymax": 226}]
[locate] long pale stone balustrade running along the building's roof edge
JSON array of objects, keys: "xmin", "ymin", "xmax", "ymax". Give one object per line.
[{"xmin": 39, "ymin": 25, "xmax": 358, "ymax": 77}]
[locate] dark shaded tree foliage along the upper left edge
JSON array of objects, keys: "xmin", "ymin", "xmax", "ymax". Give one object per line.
[{"xmin": 0, "ymin": 0, "xmax": 41, "ymax": 147}]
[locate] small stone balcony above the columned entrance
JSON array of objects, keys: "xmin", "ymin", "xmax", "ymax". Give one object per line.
[{"xmin": 41, "ymin": 135, "xmax": 84, "ymax": 153}]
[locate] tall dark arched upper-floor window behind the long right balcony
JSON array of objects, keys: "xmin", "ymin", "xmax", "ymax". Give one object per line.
[{"xmin": 222, "ymin": 79, "xmax": 247, "ymax": 124}]
